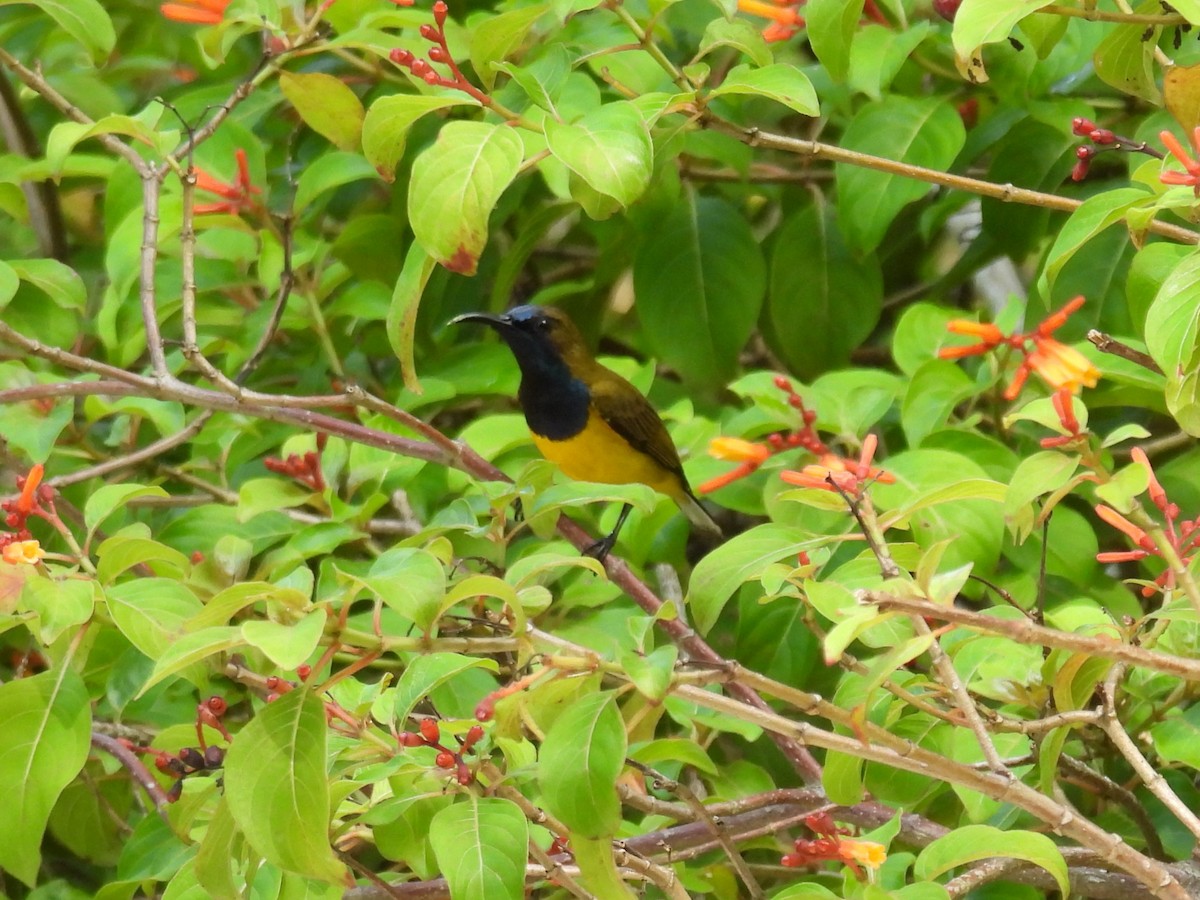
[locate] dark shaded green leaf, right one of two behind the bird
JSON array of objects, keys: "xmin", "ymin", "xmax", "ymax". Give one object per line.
[{"xmin": 763, "ymin": 202, "xmax": 883, "ymax": 379}]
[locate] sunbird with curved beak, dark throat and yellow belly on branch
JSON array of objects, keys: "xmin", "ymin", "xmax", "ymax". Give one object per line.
[{"xmin": 450, "ymin": 305, "xmax": 721, "ymax": 562}]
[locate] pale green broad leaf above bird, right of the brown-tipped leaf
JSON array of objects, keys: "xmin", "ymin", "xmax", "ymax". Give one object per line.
[{"xmin": 545, "ymin": 100, "xmax": 654, "ymax": 213}]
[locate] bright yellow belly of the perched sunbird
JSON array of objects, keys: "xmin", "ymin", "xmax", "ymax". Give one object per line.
[{"xmin": 533, "ymin": 414, "xmax": 683, "ymax": 498}]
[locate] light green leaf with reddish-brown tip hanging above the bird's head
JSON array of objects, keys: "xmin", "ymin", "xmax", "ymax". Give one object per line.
[{"xmin": 408, "ymin": 122, "xmax": 524, "ymax": 275}]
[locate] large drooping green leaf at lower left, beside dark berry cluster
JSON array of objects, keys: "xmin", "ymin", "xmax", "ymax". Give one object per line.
[{"xmin": 224, "ymin": 688, "xmax": 346, "ymax": 883}]
